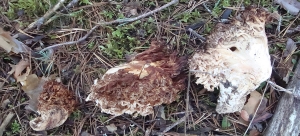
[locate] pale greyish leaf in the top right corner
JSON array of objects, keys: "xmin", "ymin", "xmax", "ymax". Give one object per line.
[{"xmin": 274, "ymin": 0, "xmax": 300, "ymax": 15}]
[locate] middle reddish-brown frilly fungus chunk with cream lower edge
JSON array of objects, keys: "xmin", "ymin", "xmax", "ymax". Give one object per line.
[{"xmin": 86, "ymin": 41, "xmax": 187, "ymax": 116}]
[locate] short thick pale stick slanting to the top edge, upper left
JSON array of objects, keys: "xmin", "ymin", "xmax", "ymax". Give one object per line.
[{"xmin": 25, "ymin": 0, "xmax": 65, "ymax": 31}]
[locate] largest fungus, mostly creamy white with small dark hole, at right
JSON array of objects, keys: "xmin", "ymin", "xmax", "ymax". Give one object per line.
[{"xmin": 189, "ymin": 6, "xmax": 272, "ymax": 113}]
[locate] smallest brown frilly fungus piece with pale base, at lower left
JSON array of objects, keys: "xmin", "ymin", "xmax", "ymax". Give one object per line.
[{"xmin": 29, "ymin": 80, "xmax": 76, "ymax": 131}]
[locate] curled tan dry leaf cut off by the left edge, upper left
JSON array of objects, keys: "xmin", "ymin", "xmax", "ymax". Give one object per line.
[{"xmin": 0, "ymin": 28, "xmax": 31, "ymax": 53}]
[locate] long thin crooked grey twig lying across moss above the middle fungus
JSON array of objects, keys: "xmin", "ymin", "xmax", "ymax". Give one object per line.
[{"xmin": 41, "ymin": 0, "xmax": 179, "ymax": 52}]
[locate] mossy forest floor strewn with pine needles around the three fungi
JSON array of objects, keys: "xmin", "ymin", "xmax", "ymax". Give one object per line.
[{"xmin": 0, "ymin": 0, "xmax": 300, "ymax": 136}]
